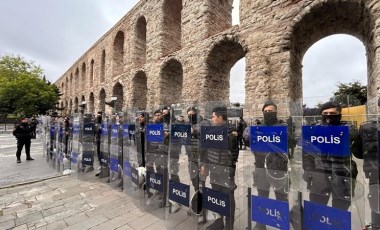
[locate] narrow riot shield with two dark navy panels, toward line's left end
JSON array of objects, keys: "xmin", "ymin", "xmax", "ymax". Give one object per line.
[{"xmin": 78, "ymin": 114, "xmax": 95, "ymax": 180}]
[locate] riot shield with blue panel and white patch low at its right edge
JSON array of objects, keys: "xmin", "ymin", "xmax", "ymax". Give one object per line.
[{"xmin": 123, "ymin": 109, "xmax": 144, "ymax": 207}]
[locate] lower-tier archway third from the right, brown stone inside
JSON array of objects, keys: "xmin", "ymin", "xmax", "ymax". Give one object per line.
[{"xmin": 159, "ymin": 59, "xmax": 183, "ymax": 105}]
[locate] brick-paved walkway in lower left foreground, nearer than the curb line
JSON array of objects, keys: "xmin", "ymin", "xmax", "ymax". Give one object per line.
[{"xmin": 0, "ymin": 176, "xmax": 165, "ymax": 230}]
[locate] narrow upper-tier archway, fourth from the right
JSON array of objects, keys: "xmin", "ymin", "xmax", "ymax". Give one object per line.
[{"xmin": 112, "ymin": 31, "xmax": 124, "ymax": 77}]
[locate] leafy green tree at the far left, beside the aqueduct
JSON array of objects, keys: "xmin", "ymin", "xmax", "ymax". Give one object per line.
[{"xmin": 0, "ymin": 55, "xmax": 60, "ymax": 115}]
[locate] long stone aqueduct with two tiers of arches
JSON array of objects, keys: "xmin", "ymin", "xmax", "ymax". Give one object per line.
[{"xmin": 55, "ymin": 0, "xmax": 380, "ymax": 113}]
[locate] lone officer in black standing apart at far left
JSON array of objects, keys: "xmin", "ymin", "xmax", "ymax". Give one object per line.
[{"xmin": 13, "ymin": 117, "xmax": 34, "ymax": 163}]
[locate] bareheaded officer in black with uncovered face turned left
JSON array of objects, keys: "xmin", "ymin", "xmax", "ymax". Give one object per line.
[{"xmin": 199, "ymin": 106, "xmax": 239, "ymax": 230}]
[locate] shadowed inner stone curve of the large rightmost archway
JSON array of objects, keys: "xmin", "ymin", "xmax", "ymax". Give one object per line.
[{"xmin": 287, "ymin": 1, "xmax": 378, "ymax": 108}]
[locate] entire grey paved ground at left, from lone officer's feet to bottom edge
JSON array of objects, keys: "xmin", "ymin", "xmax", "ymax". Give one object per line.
[{"xmin": 0, "ymin": 133, "xmax": 165, "ymax": 230}]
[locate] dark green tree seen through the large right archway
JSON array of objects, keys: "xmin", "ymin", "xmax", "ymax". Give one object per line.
[{"xmin": 331, "ymin": 80, "xmax": 367, "ymax": 107}]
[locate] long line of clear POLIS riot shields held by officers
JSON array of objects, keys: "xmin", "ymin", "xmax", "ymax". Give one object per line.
[{"xmin": 38, "ymin": 99, "xmax": 380, "ymax": 230}]
